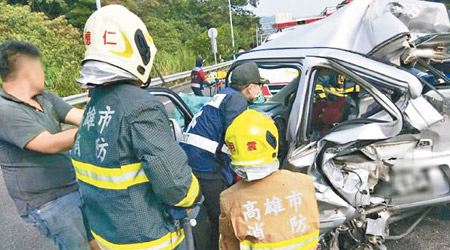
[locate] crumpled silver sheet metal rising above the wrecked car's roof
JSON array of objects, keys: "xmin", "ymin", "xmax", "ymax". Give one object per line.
[{"xmin": 256, "ymin": 0, "xmax": 450, "ymax": 57}]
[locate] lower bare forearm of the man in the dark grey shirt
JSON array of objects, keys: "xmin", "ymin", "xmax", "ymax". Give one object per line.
[{"xmin": 25, "ymin": 128, "xmax": 78, "ymax": 154}]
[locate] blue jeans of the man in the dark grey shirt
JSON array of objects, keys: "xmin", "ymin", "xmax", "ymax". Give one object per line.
[{"xmin": 22, "ymin": 191, "xmax": 90, "ymax": 250}]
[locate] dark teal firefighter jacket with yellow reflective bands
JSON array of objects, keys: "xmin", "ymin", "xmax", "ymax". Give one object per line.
[{"xmin": 71, "ymin": 83, "xmax": 199, "ymax": 250}]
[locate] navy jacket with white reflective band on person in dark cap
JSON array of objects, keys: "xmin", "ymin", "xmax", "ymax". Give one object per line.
[{"xmin": 181, "ymin": 87, "xmax": 248, "ymax": 184}]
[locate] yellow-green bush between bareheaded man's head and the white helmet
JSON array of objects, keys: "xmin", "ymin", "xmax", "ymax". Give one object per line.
[{"xmin": 0, "ymin": 2, "xmax": 84, "ymax": 96}]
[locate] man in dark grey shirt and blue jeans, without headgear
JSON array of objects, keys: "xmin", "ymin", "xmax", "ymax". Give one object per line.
[{"xmin": 0, "ymin": 41, "xmax": 95, "ymax": 249}]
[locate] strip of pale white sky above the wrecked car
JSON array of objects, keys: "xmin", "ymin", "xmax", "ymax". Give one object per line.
[{"xmin": 253, "ymin": 0, "xmax": 342, "ymax": 17}]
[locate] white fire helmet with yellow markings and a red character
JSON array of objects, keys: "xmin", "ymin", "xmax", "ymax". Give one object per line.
[{"xmin": 83, "ymin": 5, "xmax": 156, "ymax": 83}]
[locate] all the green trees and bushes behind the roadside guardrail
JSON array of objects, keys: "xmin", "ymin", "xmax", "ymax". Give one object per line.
[{"xmin": 0, "ymin": 0, "xmax": 259, "ymax": 96}]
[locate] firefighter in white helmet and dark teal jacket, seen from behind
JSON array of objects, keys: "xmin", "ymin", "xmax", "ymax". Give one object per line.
[{"xmin": 71, "ymin": 5, "xmax": 201, "ymax": 249}]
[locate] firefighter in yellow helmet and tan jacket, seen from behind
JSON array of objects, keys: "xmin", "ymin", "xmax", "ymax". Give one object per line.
[{"xmin": 220, "ymin": 110, "xmax": 319, "ymax": 250}]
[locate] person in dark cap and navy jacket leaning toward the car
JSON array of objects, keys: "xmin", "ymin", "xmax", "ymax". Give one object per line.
[{"xmin": 181, "ymin": 62, "xmax": 265, "ymax": 250}]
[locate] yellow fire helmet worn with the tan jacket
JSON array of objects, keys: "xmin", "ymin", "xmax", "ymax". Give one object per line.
[{"xmin": 225, "ymin": 109, "xmax": 278, "ymax": 168}]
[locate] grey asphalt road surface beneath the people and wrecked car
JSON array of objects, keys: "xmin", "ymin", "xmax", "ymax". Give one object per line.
[{"xmin": 0, "ymin": 83, "xmax": 450, "ymax": 250}]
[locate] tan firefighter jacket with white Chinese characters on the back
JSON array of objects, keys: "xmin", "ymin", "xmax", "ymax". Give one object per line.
[{"xmin": 220, "ymin": 170, "xmax": 320, "ymax": 250}]
